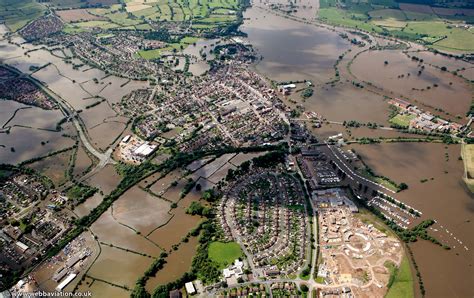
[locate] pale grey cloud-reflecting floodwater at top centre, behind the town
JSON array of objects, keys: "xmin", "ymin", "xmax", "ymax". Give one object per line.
[{"xmin": 240, "ymin": 6, "xmax": 350, "ymax": 83}]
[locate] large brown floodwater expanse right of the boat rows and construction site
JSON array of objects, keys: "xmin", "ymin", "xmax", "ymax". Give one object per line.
[{"xmin": 353, "ymin": 143, "xmax": 474, "ymax": 297}]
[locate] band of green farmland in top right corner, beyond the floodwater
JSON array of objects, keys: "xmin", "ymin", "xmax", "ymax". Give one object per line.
[{"xmin": 319, "ymin": 0, "xmax": 474, "ymax": 53}]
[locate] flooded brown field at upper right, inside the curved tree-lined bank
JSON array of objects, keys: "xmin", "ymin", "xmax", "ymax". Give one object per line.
[{"xmin": 351, "ymin": 50, "xmax": 472, "ymax": 116}]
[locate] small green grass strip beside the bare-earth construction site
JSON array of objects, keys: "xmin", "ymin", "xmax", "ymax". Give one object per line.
[{"xmin": 385, "ymin": 256, "xmax": 414, "ymax": 298}]
